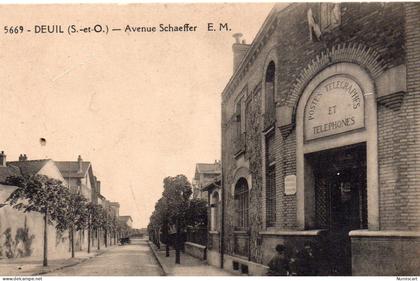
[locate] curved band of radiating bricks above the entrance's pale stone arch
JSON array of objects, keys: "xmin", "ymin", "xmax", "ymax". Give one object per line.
[{"xmin": 279, "ymin": 43, "xmax": 386, "ymax": 108}]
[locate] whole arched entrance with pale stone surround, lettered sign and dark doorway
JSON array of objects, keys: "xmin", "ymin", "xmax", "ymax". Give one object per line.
[{"xmin": 296, "ymin": 63, "xmax": 379, "ymax": 275}]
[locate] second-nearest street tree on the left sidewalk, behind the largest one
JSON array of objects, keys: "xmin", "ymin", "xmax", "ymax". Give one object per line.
[{"xmin": 57, "ymin": 189, "xmax": 89, "ymax": 258}]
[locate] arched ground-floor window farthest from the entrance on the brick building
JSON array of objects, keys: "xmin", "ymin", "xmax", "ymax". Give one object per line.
[{"xmin": 234, "ymin": 178, "xmax": 248, "ymax": 230}]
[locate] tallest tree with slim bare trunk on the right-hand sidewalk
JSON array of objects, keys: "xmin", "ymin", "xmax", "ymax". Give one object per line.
[{"xmin": 162, "ymin": 175, "xmax": 192, "ymax": 264}]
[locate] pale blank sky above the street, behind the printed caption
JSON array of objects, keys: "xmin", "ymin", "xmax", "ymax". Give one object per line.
[{"xmin": 0, "ymin": 3, "xmax": 272, "ymax": 227}]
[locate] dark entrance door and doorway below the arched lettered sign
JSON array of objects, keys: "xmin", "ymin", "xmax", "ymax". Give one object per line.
[{"xmin": 309, "ymin": 145, "xmax": 367, "ymax": 275}]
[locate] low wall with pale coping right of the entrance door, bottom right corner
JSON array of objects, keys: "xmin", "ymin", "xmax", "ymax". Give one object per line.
[{"xmin": 350, "ymin": 230, "xmax": 420, "ymax": 276}]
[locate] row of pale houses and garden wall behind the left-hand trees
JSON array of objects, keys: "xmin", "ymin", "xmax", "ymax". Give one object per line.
[{"xmin": 0, "ymin": 151, "xmax": 132, "ymax": 258}]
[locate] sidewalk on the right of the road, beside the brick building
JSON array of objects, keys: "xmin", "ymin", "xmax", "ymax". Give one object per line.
[{"xmin": 149, "ymin": 241, "xmax": 233, "ymax": 276}]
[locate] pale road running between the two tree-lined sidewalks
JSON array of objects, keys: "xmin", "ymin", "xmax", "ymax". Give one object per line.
[{"xmin": 47, "ymin": 239, "xmax": 163, "ymax": 276}]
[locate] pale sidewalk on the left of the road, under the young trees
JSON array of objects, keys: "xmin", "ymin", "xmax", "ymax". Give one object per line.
[{"xmin": 0, "ymin": 246, "xmax": 115, "ymax": 276}]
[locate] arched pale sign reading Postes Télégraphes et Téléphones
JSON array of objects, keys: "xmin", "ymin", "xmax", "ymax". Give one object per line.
[{"xmin": 304, "ymin": 75, "xmax": 364, "ymax": 140}]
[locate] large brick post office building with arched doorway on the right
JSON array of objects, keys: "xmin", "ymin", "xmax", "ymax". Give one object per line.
[{"xmin": 215, "ymin": 3, "xmax": 420, "ymax": 275}]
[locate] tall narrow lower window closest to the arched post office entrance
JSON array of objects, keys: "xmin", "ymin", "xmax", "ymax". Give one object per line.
[{"xmin": 265, "ymin": 132, "xmax": 276, "ymax": 227}]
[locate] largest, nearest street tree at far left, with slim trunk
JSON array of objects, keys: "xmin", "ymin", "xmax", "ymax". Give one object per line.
[{"xmin": 6, "ymin": 175, "xmax": 68, "ymax": 266}]
